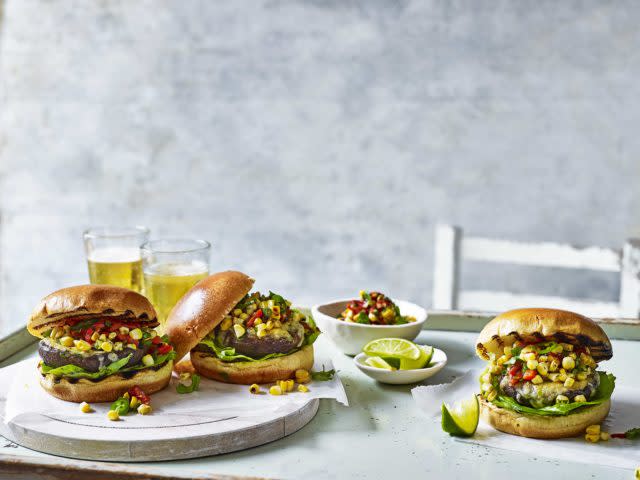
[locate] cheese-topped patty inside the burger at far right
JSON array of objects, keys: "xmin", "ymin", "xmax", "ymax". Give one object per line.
[{"xmin": 500, "ymin": 372, "xmax": 600, "ymax": 408}]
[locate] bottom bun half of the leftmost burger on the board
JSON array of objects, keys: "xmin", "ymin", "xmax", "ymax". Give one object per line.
[{"xmin": 38, "ymin": 360, "xmax": 173, "ymax": 403}]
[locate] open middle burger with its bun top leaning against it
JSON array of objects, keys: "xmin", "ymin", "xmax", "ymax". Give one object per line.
[{"xmin": 167, "ymin": 271, "xmax": 320, "ymax": 385}]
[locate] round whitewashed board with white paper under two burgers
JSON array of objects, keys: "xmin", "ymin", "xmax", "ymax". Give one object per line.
[{"xmin": 0, "ymin": 359, "xmax": 343, "ymax": 462}]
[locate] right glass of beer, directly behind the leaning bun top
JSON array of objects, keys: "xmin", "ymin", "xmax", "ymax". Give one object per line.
[{"xmin": 141, "ymin": 239, "xmax": 211, "ymax": 330}]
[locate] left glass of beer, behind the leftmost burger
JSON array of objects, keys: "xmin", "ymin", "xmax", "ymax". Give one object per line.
[{"xmin": 83, "ymin": 227, "xmax": 149, "ymax": 292}]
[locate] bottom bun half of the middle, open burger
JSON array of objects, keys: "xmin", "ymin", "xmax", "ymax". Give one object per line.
[{"xmin": 191, "ymin": 345, "xmax": 313, "ymax": 385}]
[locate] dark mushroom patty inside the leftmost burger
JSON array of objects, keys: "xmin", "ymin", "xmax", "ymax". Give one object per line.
[{"xmin": 38, "ymin": 339, "xmax": 147, "ymax": 372}]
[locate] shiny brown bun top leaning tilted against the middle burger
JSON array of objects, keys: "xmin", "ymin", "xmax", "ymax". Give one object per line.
[{"xmin": 166, "ymin": 271, "xmax": 254, "ymax": 363}]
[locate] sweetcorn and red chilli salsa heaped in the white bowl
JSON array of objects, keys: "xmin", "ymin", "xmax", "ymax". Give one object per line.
[{"xmin": 338, "ymin": 290, "xmax": 416, "ymax": 325}]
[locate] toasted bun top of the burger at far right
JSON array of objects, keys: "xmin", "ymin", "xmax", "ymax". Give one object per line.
[{"xmin": 476, "ymin": 308, "xmax": 613, "ymax": 362}]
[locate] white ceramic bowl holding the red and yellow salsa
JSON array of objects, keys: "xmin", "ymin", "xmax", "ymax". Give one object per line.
[{"xmin": 311, "ymin": 300, "xmax": 427, "ymax": 355}]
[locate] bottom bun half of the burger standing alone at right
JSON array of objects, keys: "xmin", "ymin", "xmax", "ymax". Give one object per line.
[{"xmin": 478, "ymin": 395, "xmax": 611, "ymax": 439}]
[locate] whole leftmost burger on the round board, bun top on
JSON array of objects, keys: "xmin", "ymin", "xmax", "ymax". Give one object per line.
[{"xmin": 27, "ymin": 285, "xmax": 175, "ymax": 402}]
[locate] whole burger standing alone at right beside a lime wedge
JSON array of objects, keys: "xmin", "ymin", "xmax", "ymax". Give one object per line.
[{"xmin": 476, "ymin": 308, "xmax": 615, "ymax": 438}]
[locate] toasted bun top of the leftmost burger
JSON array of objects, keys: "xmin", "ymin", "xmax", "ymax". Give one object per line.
[{"xmin": 27, "ymin": 285, "xmax": 158, "ymax": 337}]
